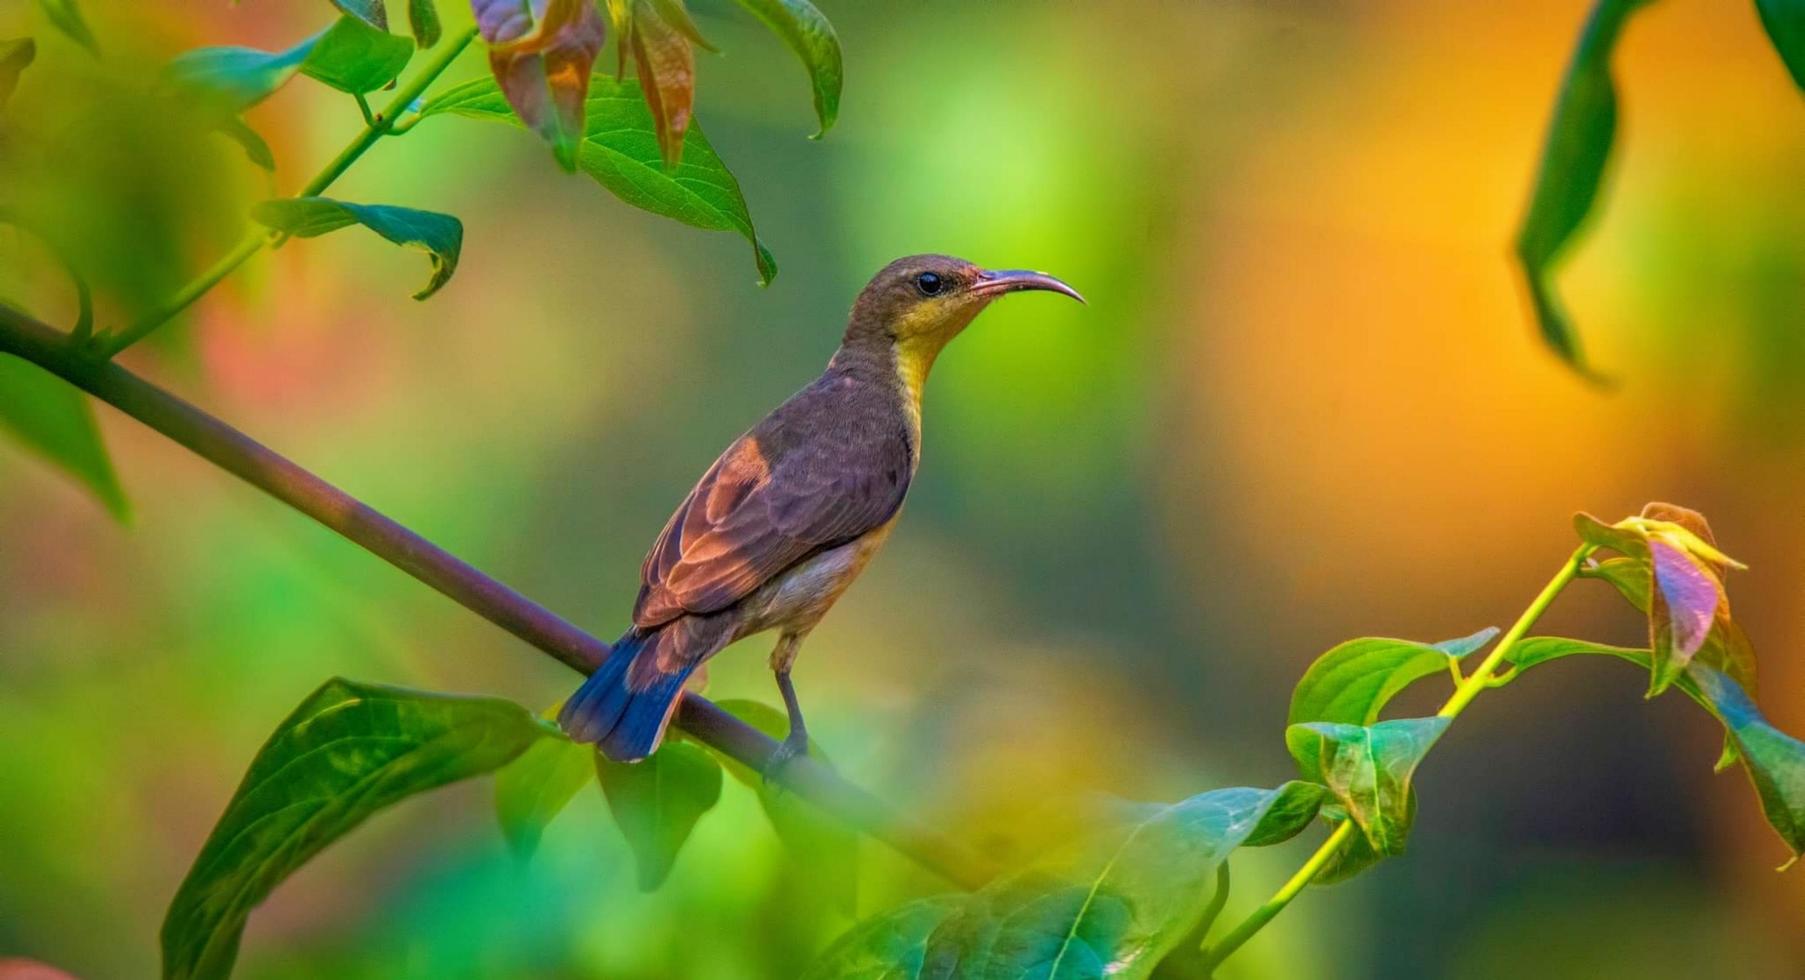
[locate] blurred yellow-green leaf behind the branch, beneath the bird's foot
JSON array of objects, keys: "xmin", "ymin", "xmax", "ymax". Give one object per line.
[{"xmin": 715, "ymin": 698, "xmax": 859, "ymax": 913}]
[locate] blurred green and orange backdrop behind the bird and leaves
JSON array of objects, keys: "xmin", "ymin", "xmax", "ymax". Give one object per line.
[{"xmin": 0, "ymin": 0, "xmax": 1805, "ymax": 978}]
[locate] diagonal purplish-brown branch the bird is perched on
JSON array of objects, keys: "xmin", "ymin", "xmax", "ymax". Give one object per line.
[{"xmin": 0, "ymin": 305, "xmax": 995, "ymax": 888}]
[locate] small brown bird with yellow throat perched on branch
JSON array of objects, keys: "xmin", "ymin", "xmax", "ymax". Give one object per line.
[{"xmin": 558, "ymin": 254, "xmax": 1083, "ymax": 767}]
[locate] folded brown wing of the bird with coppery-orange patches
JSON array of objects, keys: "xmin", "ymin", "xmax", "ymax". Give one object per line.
[{"xmin": 634, "ymin": 379, "xmax": 912, "ymax": 628}]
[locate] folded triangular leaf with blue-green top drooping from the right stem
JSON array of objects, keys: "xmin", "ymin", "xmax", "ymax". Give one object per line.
[{"xmin": 1285, "ymin": 718, "xmax": 1448, "ymax": 855}]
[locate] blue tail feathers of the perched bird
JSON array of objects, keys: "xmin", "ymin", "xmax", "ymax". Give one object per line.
[{"xmin": 558, "ymin": 630, "xmax": 695, "ymax": 762}]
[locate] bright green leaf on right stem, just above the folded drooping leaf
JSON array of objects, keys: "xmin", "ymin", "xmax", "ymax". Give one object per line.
[{"xmin": 1285, "ymin": 626, "xmax": 1498, "ymax": 726}]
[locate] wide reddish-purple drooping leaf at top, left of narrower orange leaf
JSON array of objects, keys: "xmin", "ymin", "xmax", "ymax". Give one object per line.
[{"xmin": 471, "ymin": 0, "xmax": 606, "ymax": 171}]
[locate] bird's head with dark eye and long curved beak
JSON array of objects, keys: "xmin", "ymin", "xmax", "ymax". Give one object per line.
[{"xmin": 847, "ymin": 254, "xmax": 1085, "ymax": 384}]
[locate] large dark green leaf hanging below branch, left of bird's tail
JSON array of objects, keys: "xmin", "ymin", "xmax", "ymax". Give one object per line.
[{"xmin": 162, "ymin": 679, "xmax": 547, "ymax": 980}]
